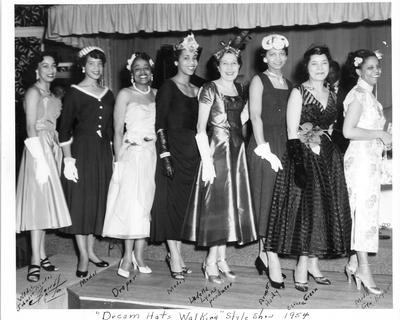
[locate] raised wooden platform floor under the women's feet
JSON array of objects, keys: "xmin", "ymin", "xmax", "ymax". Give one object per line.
[{"xmin": 67, "ymin": 261, "xmax": 393, "ymax": 310}]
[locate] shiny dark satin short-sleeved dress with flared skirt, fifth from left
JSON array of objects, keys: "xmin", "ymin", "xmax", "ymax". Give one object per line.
[{"xmin": 182, "ymin": 82, "xmax": 257, "ymax": 246}]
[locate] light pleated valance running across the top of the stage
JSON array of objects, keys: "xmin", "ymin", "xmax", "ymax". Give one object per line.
[{"xmin": 46, "ymin": 2, "xmax": 391, "ymax": 39}]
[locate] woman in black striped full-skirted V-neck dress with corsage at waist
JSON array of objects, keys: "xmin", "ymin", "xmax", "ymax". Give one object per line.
[{"xmin": 265, "ymin": 45, "xmax": 351, "ymax": 292}]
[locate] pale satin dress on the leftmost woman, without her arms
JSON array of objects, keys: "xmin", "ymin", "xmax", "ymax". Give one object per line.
[{"xmin": 15, "ymin": 95, "xmax": 71, "ymax": 233}]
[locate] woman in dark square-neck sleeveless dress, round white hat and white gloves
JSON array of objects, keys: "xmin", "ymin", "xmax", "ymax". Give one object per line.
[{"xmin": 247, "ymin": 34, "xmax": 292, "ymax": 288}]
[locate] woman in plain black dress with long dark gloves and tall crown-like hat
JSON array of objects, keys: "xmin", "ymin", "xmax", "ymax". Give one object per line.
[{"xmin": 150, "ymin": 35, "xmax": 199, "ymax": 279}]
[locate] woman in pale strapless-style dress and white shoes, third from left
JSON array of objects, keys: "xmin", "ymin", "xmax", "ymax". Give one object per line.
[{"xmin": 102, "ymin": 52, "xmax": 157, "ymax": 278}]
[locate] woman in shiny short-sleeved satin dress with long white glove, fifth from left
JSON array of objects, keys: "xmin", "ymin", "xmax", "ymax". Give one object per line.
[{"xmin": 182, "ymin": 37, "xmax": 257, "ymax": 284}]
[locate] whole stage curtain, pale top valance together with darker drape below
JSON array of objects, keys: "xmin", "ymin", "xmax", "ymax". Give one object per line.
[{"xmin": 46, "ymin": 2, "xmax": 392, "ymax": 106}]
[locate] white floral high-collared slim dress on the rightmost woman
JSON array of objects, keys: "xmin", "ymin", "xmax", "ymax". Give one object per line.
[{"xmin": 343, "ymin": 79, "xmax": 386, "ymax": 252}]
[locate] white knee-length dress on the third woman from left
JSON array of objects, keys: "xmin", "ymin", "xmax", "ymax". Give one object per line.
[{"xmin": 103, "ymin": 102, "xmax": 157, "ymax": 239}]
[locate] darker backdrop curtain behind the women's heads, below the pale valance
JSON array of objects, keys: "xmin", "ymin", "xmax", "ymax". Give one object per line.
[{"xmin": 109, "ymin": 21, "xmax": 392, "ymax": 107}]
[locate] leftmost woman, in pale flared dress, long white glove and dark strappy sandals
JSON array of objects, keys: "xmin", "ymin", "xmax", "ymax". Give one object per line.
[{"xmin": 15, "ymin": 52, "xmax": 71, "ymax": 282}]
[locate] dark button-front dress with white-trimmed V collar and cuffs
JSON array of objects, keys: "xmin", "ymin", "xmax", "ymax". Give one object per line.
[{"xmin": 59, "ymin": 85, "xmax": 114, "ymax": 235}]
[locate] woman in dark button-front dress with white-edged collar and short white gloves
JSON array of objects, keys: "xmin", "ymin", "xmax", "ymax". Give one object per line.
[{"xmin": 60, "ymin": 47, "xmax": 114, "ymax": 277}]
